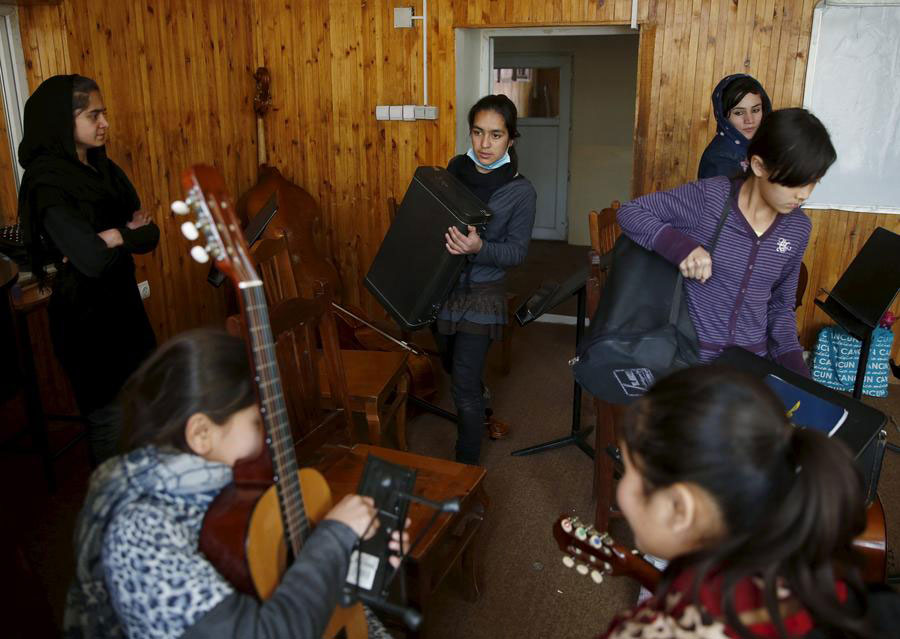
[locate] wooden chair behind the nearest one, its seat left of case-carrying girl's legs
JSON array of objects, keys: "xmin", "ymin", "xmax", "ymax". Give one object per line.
[{"xmin": 251, "ymin": 231, "xmax": 409, "ymax": 450}]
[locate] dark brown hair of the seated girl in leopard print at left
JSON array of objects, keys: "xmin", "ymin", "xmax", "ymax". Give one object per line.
[{"xmin": 121, "ymin": 329, "xmax": 256, "ymax": 452}]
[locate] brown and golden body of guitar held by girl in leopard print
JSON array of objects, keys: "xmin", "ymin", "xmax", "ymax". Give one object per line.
[{"xmin": 200, "ymin": 468, "xmax": 369, "ymax": 639}]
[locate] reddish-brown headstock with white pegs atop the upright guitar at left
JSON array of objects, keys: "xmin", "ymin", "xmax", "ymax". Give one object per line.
[{"xmin": 171, "ymin": 164, "xmax": 259, "ymax": 286}]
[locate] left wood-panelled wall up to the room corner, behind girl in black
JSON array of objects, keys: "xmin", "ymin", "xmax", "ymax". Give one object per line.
[{"xmin": 19, "ymin": 0, "xmax": 256, "ymax": 339}]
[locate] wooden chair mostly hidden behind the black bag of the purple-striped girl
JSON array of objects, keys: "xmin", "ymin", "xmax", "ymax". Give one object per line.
[{"xmin": 587, "ymin": 200, "xmax": 625, "ymax": 530}]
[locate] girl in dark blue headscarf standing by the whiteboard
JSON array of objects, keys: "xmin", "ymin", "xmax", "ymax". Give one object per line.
[{"xmin": 697, "ymin": 73, "xmax": 772, "ymax": 179}]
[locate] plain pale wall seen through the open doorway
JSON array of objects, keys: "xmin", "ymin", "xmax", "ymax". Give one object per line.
[{"xmin": 494, "ymin": 33, "xmax": 638, "ymax": 246}]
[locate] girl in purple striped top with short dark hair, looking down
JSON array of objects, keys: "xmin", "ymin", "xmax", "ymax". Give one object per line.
[{"xmin": 618, "ymin": 109, "xmax": 837, "ymax": 377}]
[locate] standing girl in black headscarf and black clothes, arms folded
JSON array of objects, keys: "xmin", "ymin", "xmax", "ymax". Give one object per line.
[{"xmin": 19, "ymin": 75, "xmax": 159, "ymax": 463}]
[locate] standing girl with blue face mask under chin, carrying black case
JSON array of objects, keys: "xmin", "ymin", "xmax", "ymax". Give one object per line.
[{"xmin": 434, "ymin": 95, "xmax": 537, "ymax": 464}]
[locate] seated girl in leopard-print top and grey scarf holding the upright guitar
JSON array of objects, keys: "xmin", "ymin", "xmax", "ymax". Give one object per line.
[{"xmin": 65, "ymin": 330, "xmax": 408, "ymax": 639}]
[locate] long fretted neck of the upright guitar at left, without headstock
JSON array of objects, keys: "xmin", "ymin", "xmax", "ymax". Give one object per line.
[{"xmin": 239, "ymin": 281, "xmax": 310, "ymax": 557}]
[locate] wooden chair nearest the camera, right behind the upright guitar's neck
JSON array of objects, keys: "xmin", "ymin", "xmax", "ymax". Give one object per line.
[{"xmin": 270, "ymin": 287, "xmax": 489, "ymax": 636}]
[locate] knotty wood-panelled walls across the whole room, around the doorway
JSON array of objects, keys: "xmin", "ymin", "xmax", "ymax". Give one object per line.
[{"xmin": 20, "ymin": 0, "xmax": 900, "ymax": 360}]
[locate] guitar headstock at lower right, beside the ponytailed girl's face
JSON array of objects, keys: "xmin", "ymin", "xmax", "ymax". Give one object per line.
[{"xmin": 553, "ymin": 515, "xmax": 660, "ymax": 590}]
